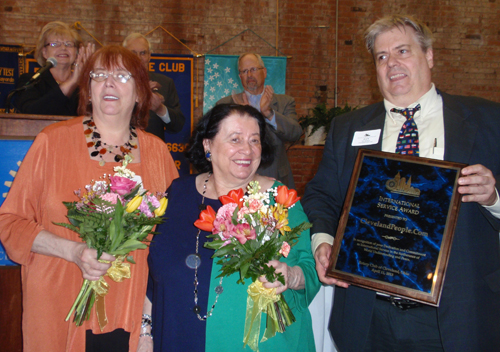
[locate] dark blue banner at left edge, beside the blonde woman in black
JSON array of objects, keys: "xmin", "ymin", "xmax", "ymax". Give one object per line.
[{"xmin": 0, "ymin": 45, "xmax": 24, "ymax": 112}]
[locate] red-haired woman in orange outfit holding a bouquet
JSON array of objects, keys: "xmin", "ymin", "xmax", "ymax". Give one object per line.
[{"xmin": 0, "ymin": 45, "xmax": 178, "ymax": 352}]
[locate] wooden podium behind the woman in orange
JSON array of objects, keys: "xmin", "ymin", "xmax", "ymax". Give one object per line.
[{"xmin": 0, "ymin": 113, "xmax": 74, "ymax": 352}]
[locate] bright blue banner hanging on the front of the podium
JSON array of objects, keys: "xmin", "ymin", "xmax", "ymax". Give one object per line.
[{"xmin": 0, "ymin": 139, "xmax": 33, "ymax": 265}]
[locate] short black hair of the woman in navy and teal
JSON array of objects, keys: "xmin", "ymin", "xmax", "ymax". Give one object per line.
[{"xmin": 186, "ymin": 104, "xmax": 274, "ymax": 172}]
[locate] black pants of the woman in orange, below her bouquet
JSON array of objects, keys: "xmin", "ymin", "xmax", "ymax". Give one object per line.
[{"xmin": 85, "ymin": 329, "xmax": 130, "ymax": 352}]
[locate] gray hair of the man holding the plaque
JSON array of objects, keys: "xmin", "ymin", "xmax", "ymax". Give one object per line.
[{"xmin": 365, "ymin": 15, "xmax": 434, "ymax": 56}]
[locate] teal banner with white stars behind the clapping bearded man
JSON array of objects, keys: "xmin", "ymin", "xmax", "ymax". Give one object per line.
[{"xmin": 203, "ymin": 55, "xmax": 286, "ymax": 114}]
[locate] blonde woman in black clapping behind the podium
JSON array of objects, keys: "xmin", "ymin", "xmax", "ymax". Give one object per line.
[{"xmin": 14, "ymin": 21, "xmax": 95, "ymax": 116}]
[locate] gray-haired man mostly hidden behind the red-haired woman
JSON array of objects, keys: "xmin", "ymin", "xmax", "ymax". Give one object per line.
[{"xmin": 122, "ymin": 33, "xmax": 186, "ymax": 140}]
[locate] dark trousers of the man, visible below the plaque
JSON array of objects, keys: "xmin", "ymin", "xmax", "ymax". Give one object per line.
[{"xmin": 364, "ymin": 299, "xmax": 444, "ymax": 352}]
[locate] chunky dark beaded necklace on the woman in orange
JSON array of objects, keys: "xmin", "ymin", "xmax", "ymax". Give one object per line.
[{"xmin": 83, "ymin": 117, "xmax": 137, "ymax": 166}]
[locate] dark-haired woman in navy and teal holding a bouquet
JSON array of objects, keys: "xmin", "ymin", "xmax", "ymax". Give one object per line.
[{"xmin": 141, "ymin": 104, "xmax": 320, "ymax": 352}]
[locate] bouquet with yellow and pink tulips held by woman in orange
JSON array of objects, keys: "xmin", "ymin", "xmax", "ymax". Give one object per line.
[{"xmin": 56, "ymin": 154, "xmax": 168, "ymax": 330}]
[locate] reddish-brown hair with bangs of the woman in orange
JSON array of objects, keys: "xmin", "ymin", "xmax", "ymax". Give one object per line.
[{"xmin": 78, "ymin": 45, "xmax": 153, "ymax": 129}]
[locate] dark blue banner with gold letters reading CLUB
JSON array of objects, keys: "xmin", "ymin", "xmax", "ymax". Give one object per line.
[{"xmin": 149, "ymin": 54, "xmax": 193, "ymax": 175}]
